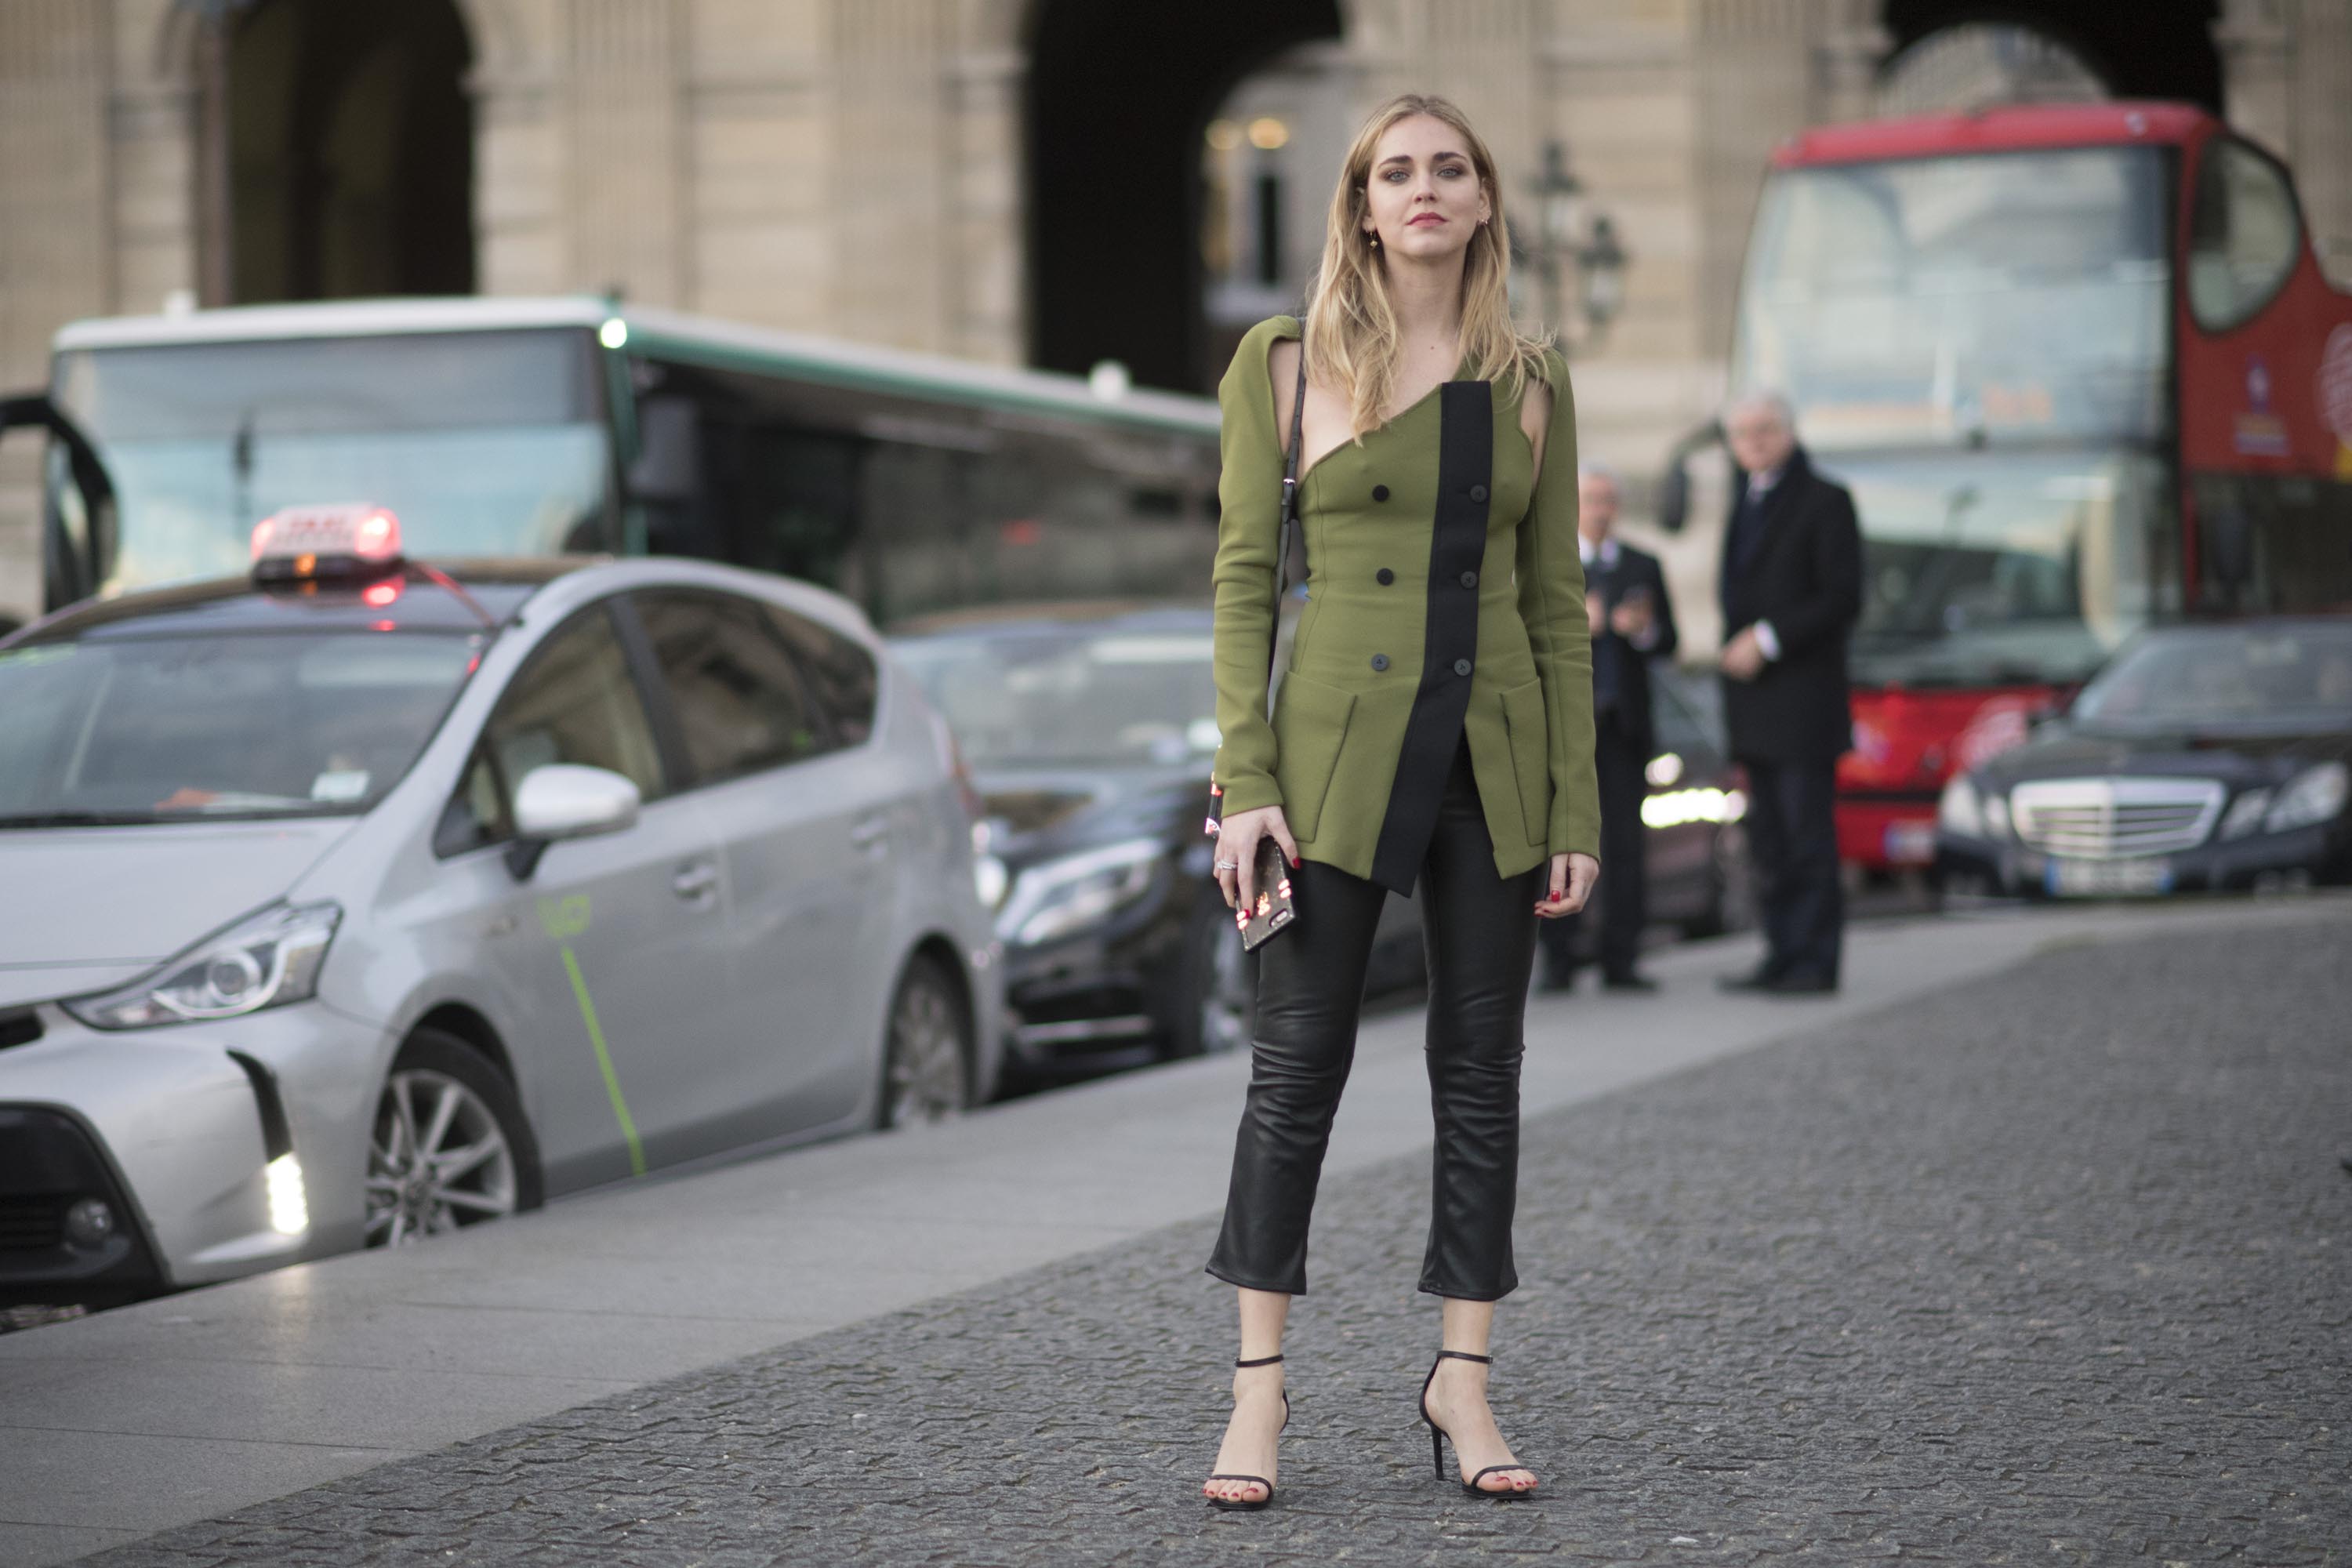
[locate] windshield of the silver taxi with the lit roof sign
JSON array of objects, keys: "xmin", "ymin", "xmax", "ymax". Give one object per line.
[{"xmin": 0, "ymin": 633, "xmax": 480, "ymax": 827}]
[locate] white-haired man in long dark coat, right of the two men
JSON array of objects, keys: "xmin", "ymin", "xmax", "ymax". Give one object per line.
[{"xmin": 1722, "ymin": 393, "xmax": 1863, "ymax": 994}]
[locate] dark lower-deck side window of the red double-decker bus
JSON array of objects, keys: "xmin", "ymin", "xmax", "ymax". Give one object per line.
[{"xmin": 2190, "ymin": 473, "xmax": 2352, "ymax": 614}]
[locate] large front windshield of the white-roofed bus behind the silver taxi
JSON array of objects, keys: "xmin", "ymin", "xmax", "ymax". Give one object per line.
[{"xmin": 52, "ymin": 329, "xmax": 609, "ymax": 593}]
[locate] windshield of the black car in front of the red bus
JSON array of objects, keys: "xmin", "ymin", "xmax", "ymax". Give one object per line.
[{"xmin": 2067, "ymin": 623, "xmax": 2352, "ymax": 731}]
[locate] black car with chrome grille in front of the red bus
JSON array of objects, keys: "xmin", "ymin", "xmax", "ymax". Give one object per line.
[{"xmin": 1936, "ymin": 616, "xmax": 2352, "ymax": 898}]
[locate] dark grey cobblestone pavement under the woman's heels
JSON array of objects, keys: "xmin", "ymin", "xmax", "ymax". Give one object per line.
[{"xmin": 85, "ymin": 914, "xmax": 2352, "ymax": 1568}]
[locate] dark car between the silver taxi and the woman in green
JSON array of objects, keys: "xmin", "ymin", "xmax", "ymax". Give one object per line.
[{"xmin": 891, "ymin": 602, "xmax": 1421, "ymax": 1067}]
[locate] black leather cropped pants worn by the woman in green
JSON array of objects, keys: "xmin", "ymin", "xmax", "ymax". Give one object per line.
[{"xmin": 1209, "ymin": 743, "xmax": 1545, "ymax": 1300}]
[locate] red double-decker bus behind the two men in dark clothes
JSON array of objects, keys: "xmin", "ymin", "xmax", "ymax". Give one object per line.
[{"xmin": 1733, "ymin": 103, "xmax": 2352, "ymax": 869}]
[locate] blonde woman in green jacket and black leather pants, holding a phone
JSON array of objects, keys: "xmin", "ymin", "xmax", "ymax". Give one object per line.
[{"xmin": 1202, "ymin": 96, "xmax": 1599, "ymax": 1509}]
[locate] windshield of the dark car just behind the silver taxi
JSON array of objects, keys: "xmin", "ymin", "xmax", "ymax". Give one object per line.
[{"xmin": 896, "ymin": 628, "xmax": 1216, "ymax": 769}]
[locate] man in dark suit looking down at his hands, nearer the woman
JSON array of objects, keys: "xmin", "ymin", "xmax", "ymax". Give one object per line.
[{"xmin": 1536, "ymin": 463, "xmax": 1675, "ymax": 992}]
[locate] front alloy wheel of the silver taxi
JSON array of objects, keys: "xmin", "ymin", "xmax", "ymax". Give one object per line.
[{"xmin": 367, "ymin": 1067, "xmax": 520, "ymax": 1246}]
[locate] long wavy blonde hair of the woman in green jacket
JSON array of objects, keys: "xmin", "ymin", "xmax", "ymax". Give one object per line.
[{"xmin": 1305, "ymin": 92, "xmax": 1545, "ymax": 437}]
